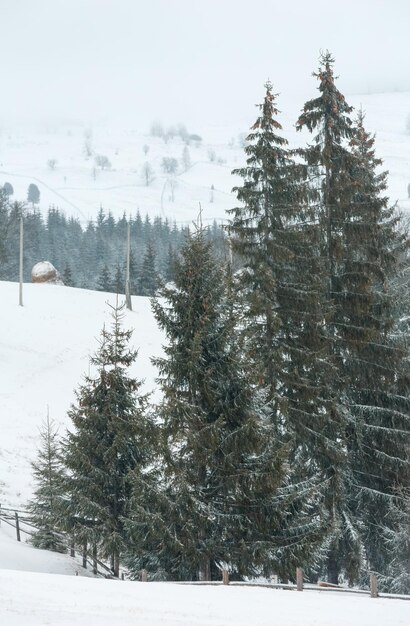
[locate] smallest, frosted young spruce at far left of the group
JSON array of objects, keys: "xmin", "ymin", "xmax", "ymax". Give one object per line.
[{"xmin": 28, "ymin": 415, "xmax": 67, "ymax": 552}]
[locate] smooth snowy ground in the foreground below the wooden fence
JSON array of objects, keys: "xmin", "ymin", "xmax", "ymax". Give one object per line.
[{"xmin": 0, "ymin": 570, "xmax": 410, "ymax": 626}]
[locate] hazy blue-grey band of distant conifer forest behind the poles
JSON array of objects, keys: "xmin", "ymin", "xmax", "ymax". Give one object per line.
[{"xmin": 0, "ymin": 192, "xmax": 226, "ymax": 296}]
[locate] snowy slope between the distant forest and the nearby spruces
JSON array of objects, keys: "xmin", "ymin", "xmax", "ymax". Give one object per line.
[{"xmin": 0, "ymin": 282, "xmax": 161, "ymax": 507}]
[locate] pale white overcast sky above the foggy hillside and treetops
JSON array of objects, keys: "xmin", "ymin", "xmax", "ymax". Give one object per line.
[{"xmin": 0, "ymin": 0, "xmax": 410, "ymax": 126}]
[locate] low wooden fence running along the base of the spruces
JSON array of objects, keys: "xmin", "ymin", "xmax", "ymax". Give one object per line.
[{"xmin": 0, "ymin": 504, "xmax": 410, "ymax": 600}]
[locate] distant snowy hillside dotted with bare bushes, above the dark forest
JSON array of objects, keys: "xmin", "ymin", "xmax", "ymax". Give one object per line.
[{"xmin": 0, "ymin": 89, "xmax": 410, "ymax": 223}]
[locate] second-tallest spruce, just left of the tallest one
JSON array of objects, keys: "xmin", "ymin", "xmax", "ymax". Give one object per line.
[{"xmin": 229, "ymin": 83, "xmax": 346, "ymax": 566}]
